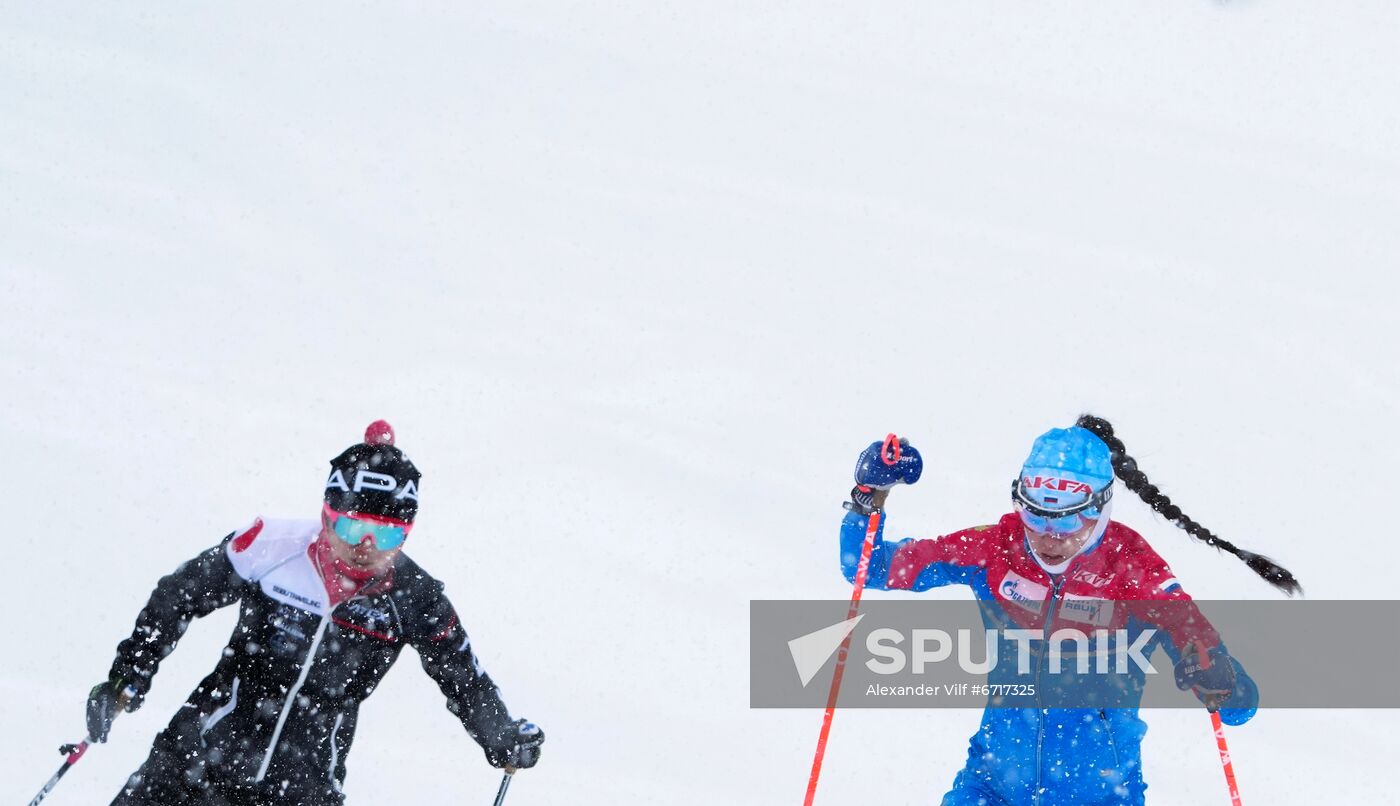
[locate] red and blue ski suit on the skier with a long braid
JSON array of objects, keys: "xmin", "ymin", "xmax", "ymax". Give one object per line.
[{"xmin": 841, "ymin": 512, "xmax": 1259, "ymax": 806}]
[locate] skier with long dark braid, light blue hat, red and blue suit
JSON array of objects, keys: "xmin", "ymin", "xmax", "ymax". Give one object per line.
[{"xmin": 841, "ymin": 416, "xmax": 1298, "ymax": 806}]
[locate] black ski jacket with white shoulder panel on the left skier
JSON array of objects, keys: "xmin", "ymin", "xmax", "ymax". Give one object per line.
[{"xmin": 111, "ymin": 519, "xmax": 515, "ymax": 803}]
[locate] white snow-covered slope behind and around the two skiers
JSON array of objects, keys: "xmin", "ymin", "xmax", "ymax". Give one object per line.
[{"xmin": 0, "ymin": 0, "xmax": 1400, "ymax": 806}]
